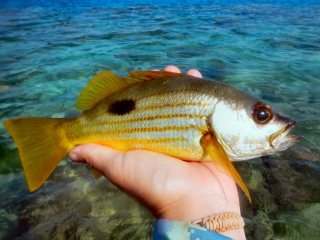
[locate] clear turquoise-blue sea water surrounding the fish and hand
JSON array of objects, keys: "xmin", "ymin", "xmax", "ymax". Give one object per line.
[{"xmin": 0, "ymin": 1, "xmax": 320, "ymax": 239}]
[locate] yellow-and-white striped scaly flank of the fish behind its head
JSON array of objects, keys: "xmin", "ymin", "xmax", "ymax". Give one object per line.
[{"xmin": 67, "ymin": 94, "xmax": 209, "ymax": 160}]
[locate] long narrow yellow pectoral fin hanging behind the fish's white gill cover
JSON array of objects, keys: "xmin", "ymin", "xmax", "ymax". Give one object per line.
[{"xmin": 200, "ymin": 133, "xmax": 251, "ymax": 203}]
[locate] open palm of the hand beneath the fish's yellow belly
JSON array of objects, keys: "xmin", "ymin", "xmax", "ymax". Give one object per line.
[{"xmin": 115, "ymin": 151, "xmax": 239, "ymax": 220}]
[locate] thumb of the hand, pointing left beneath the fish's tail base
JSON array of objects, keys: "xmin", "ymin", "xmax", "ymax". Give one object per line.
[{"xmin": 69, "ymin": 143, "xmax": 124, "ymax": 182}]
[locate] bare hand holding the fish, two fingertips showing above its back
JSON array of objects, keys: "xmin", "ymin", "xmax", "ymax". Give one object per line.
[{"xmin": 69, "ymin": 66, "xmax": 245, "ymax": 239}]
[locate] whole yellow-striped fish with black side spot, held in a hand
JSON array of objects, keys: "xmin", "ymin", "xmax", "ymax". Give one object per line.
[{"xmin": 4, "ymin": 71, "xmax": 298, "ymax": 201}]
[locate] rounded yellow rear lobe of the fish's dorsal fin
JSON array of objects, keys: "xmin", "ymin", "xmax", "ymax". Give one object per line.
[{"xmin": 76, "ymin": 71, "xmax": 128, "ymax": 110}]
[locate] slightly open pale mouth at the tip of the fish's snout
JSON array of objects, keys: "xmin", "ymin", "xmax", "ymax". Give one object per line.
[{"xmin": 269, "ymin": 121, "xmax": 300, "ymax": 151}]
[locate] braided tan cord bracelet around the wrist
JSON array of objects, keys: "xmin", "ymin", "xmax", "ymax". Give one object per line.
[{"xmin": 191, "ymin": 212, "xmax": 244, "ymax": 232}]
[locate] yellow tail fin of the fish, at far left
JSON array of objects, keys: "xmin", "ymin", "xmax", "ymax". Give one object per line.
[{"xmin": 4, "ymin": 118, "xmax": 69, "ymax": 192}]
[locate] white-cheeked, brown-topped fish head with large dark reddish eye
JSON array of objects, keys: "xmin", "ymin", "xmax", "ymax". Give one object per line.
[{"xmin": 207, "ymin": 96, "xmax": 299, "ymax": 161}]
